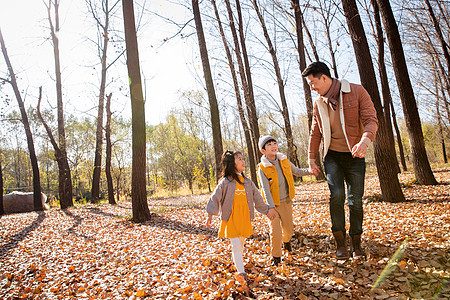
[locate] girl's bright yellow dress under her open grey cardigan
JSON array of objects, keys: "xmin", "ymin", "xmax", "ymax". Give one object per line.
[{"xmin": 219, "ymin": 176, "xmax": 253, "ymax": 238}]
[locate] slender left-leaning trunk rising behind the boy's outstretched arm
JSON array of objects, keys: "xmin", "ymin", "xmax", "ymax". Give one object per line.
[{"xmin": 252, "ymin": 0, "xmax": 300, "ymax": 167}]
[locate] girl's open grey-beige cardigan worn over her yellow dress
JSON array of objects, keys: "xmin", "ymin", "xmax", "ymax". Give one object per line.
[{"xmin": 206, "ymin": 177, "xmax": 269, "ymax": 221}]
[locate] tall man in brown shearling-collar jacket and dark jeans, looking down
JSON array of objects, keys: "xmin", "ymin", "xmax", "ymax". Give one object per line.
[{"xmin": 302, "ymin": 62, "xmax": 378, "ymax": 259}]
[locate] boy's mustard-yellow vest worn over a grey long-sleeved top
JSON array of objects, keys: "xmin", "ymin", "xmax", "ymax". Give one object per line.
[{"xmin": 258, "ymin": 158, "xmax": 295, "ymax": 205}]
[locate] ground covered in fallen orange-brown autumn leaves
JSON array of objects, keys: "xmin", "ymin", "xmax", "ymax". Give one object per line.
[{"xmin": 0, "ymin": 168, "xmax": 450, "ymax": 299}]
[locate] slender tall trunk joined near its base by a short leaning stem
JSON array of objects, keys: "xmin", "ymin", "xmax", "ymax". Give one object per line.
[{"xmin": 47, "ymin": 0, "xmax": 73, "ymax": 209}]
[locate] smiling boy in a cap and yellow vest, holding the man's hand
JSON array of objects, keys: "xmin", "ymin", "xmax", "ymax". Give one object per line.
[{"xmin": 258, "ymin": 135, "xmax": 312, "ymax": 266}]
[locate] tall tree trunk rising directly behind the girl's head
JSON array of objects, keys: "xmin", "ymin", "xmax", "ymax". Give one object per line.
[{"xmin": 192, "ymin": 0, "xmax": 223, "ymax": 181}]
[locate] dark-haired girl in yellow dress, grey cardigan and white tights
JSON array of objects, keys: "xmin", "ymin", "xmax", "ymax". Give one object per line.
[{"xmin": 206, "ymin": 151, "xmax": 275, "ymax": 284}]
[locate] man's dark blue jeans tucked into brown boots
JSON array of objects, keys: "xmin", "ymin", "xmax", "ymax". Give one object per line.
[{"xmin": 323, "ymin": 150, "xmax": 366, "ymax": 236}]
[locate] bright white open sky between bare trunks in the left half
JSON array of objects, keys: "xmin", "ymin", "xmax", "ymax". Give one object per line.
[{"xmin": 0, "ymin": 0, "xmax": 197, "ymax": 125}]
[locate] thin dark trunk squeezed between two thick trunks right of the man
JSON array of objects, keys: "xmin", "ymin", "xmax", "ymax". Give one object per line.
[{"xmin": 371, "ymin": 0, "xmax": 400, "ymax": 173}]
